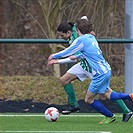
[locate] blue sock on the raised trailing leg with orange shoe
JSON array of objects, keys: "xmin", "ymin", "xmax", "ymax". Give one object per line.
[{"xmin": 110, "ymin": 91, "xmax": 132, "ymax": 101}]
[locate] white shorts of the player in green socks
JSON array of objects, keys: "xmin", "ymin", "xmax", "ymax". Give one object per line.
[{"xmin": 67, "ymin": 62, "xmax": 93, "ymax": 82}]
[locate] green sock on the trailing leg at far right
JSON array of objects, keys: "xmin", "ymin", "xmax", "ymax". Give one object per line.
[{"xmin": 114, "ymin": 100, "xmax": 130, "ymax": 114}]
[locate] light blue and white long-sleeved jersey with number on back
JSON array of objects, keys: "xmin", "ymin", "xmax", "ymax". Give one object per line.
[{"xmin": 53, "ymin": 34, "xmax": 111, "ymax": 75}]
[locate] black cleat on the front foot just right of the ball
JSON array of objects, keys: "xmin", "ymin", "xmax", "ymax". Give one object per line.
[{"xmin": 62, "ymin": 106, "xmax": 80, "ymax": 115}]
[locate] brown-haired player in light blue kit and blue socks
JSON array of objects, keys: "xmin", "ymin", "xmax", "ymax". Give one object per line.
[{"xmin": 48, "ymin": 20, "xmax": 133, "ymax": 122}]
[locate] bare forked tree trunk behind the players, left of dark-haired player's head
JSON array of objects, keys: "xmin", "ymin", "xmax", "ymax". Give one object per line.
[{"xmin": 38, "ymin": 0, "xmax": 64, "ymax": 77}]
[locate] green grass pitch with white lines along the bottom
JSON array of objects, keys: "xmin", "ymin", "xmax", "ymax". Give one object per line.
[{"xmin": 0, "ymin": 113, "xmax": 133, "ymax": 133}]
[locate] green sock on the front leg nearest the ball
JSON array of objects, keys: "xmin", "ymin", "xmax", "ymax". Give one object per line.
[{"xmin": 64, "ymin": 83, "xmax": 78, "ymax": 106}]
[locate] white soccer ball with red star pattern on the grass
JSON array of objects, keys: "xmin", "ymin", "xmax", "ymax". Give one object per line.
[{"xmin": 44, "ymin": 107, "xmax": 60, "ymax": 122}]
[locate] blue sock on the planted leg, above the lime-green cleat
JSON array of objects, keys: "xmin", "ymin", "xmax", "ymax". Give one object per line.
[{"xmin": 90, "ymin": 100, "xmax": 113, "ymax": 117}]
